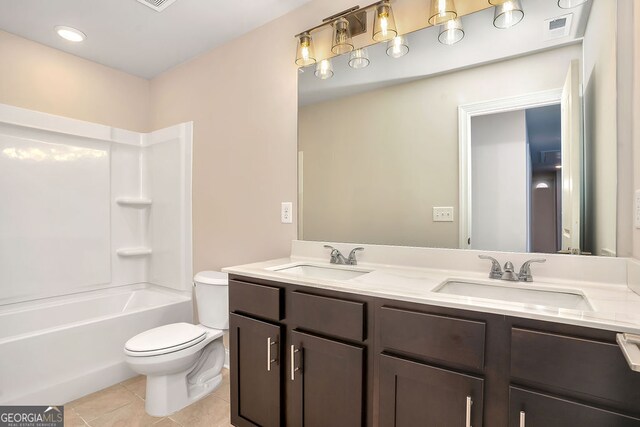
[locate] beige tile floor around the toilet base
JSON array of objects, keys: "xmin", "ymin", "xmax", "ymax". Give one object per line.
[{"xmin": 64, "ymin": 369, "xmax": 231, "ymax": 427}]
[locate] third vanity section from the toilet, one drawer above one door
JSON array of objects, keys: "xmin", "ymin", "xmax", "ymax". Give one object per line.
[{"xmin": 376, "ymin": 305, "xmax": 486, "ymax": 427}]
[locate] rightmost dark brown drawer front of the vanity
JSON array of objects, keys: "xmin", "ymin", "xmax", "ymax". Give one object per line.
[{"xmin": 511, "ymin": 328, "xmax": 640, "ymax": 413}]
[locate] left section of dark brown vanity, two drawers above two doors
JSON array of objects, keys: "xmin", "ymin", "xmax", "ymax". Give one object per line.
[{"xmin": 229, "ymin": 277, "xmax": 372, "ymax": 427}]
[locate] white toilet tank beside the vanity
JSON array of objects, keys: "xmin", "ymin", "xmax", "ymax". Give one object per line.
[{"xmin": 193, "ymin": 271, "xmax": 229, "ymax": 329}]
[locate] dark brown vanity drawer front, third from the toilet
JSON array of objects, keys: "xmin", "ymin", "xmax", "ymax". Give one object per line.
[{"xmin": 378, "ymin": 307, "xmax": 485, "ymax": 371}]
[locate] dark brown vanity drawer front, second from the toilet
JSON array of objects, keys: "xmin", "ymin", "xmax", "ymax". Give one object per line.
[{"xmin": 290, "ymin": 291, "xmax": 366, "ymax": 341}]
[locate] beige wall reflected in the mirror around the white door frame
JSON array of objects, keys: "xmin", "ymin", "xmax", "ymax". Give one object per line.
[{"xmin": 299, "ymin": 45, "xmax": 582, "ymax": 248}]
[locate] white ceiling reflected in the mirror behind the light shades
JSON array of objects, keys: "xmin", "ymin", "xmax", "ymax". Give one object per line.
[{"xmin": 298, "ymin": 0, "xmax": 596, "ymax": 106}]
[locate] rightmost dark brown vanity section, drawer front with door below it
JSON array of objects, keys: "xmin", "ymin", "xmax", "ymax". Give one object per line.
[{"xmin": 509, "ymin": 322, "xmax": 640, "ymax": 427}]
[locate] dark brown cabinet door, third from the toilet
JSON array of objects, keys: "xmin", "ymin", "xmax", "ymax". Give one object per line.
[{"xmin": 379, "ymin": 354, "xmax": 484, "ymax": 427}]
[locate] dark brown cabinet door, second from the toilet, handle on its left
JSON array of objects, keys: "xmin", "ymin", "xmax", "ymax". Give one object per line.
[{"xmin": 287, "ymin": 331, "xmax": 365, "ymax": 427}]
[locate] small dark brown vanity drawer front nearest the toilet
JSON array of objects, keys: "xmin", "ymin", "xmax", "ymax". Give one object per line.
[{"xmin": 229, "ymin": 280, "xmax": 284, "ymax": 320}]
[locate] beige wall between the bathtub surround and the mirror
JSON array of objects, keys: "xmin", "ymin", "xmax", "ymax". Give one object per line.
[{"xmin": 151, "ymin": 0, "xmax": 348, "ymax": 271}]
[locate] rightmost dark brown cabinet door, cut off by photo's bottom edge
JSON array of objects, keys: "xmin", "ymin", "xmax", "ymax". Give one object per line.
[{"xmin": 509, "ymin": 387, "xmax": 640, "ymax": 427}]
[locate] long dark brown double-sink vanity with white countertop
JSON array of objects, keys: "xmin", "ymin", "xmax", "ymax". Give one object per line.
[{"xmin": 227, "ymin": 244, "xmax": 640, "ymax": 427}]
